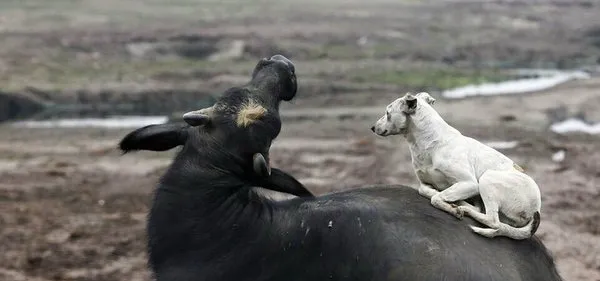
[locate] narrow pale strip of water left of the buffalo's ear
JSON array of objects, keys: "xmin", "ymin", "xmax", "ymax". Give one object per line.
[{"xmin": 11, "ymin": 116, "xmax": 168, "ymax": 128}]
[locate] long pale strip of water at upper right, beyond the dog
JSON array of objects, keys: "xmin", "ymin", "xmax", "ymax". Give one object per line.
[{"xmin": 442, "ymin": 69, "xmax": 590, "ymax": 99}]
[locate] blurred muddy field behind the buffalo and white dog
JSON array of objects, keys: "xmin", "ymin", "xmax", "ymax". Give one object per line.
[{"xmin": 0, "ymin": 0, "xmax": 600, "ymax": 281}]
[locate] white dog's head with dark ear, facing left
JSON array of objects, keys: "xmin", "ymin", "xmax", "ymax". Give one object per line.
[{"xmin": 371, "ymin": 92, "xmax": 435, "ymax": 136}]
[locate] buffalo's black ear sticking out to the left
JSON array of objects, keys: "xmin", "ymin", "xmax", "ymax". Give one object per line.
[{"xmin": 119, "ymin": 124, "xmax": 189, "ymax": 153}]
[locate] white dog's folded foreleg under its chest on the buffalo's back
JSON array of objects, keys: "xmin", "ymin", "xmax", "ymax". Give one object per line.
[{"xmin": 431, "ymin": 181, "xmax": 478, "ymax": 219}]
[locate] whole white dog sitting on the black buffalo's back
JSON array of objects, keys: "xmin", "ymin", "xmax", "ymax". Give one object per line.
[{"xmin": 371, "ymin": 92, "xmax": 541, "ymax": 239}]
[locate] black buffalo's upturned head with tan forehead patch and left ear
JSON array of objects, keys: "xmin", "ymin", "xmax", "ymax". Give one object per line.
[{"xmin": 120, "ymin": 55, "xmax": 297, "ymax": 175}]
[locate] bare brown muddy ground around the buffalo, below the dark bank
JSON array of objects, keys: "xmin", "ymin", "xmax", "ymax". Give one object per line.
[{"xmin": 0, "ymin": 77, "xmax": 600, "ymax": 281}]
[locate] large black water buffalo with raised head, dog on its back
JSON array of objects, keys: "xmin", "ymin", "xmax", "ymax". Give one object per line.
[{"xmin": 120, "ymin": 56, "xmax": 561, "ymax": 281}]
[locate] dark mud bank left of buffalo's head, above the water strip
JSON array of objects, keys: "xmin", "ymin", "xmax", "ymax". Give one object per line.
[{"xmin": 0, "ymin": 88, "xmax": 214, "ymax": 122}]
